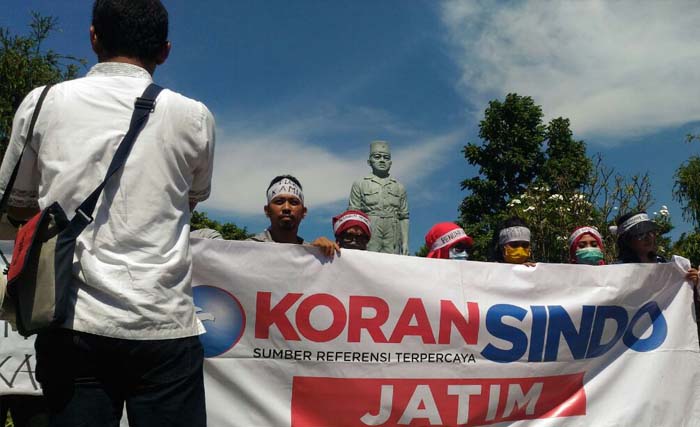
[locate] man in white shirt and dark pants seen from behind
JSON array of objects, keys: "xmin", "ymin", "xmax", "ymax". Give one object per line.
[{"xmin": 0, "ymin": 0, "xmax": 214, "ymax": 427}]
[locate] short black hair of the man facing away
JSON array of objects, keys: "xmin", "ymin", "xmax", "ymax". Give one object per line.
[{"xmin": 92, "ymin": 0, "xmax": 168, "ymax": 61}]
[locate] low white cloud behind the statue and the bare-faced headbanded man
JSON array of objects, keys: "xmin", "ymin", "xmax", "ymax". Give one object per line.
[{"xmin": 204, "ymin": 110, "xmax": 463, "ymax": 215}]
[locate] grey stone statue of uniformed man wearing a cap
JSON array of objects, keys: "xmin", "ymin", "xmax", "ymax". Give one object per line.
[{"xmin": 348, "ymin": 141, "xmax": 408, "ymax": 255}]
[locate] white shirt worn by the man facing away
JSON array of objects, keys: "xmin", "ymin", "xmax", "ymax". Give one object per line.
[{"xmin": 0, "ymin": 63, "xmax": 214, "ymax": 339}]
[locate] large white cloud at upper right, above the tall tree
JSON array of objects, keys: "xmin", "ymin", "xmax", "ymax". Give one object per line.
[{"xmin": 441, "ymin": 0, "xmax": 700, "ymax": 137}]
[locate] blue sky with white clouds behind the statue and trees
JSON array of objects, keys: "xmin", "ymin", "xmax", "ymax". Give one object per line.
[{"xmin": 0, "ymin": 0, "xmax": 700, "ymax": 252}]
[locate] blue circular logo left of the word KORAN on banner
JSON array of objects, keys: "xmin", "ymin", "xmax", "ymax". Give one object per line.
[{"xmin": 192, "ymin": 286, "xmax": 245, "ymax": 357}]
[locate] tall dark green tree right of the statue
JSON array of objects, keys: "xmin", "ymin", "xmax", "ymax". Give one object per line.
[{"xmin": 460, "ymin": 94, "xmax": 592, "ymax": 261}]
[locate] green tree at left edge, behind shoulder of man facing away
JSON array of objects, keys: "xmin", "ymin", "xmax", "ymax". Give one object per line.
[{"xmin": 0, "ymin": 12, "xmax": 86, "ymax": 158}]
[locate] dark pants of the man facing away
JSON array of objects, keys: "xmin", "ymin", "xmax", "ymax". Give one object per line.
[{"xmin": 35, "ymin": 329, "xmax": 206, "ymax": 427}]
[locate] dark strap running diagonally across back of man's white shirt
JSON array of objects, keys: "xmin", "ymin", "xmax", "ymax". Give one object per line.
[{"xmin": 66, "ymin": 83, "xmax": 163, "ymax": 237}]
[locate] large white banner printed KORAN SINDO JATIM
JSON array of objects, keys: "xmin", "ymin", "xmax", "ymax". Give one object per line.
[{"xmin": 192, "ymin": 240, "xmax": 700, "ymax": 427}]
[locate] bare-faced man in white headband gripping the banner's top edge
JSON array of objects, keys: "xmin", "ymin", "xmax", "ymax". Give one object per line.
[{"xmin": 248, "ymin": 175, "xmax": 340, "ymax": 257}]
